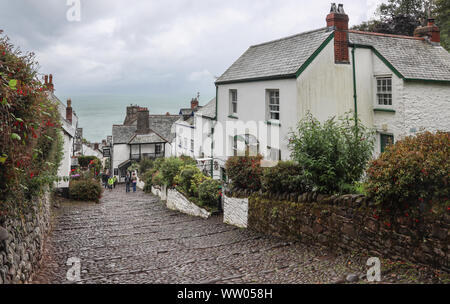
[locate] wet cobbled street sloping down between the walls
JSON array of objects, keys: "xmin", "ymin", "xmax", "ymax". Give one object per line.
[{"xmin": 33, "ymin": 187, "xmax": 446, "ymax": 284}]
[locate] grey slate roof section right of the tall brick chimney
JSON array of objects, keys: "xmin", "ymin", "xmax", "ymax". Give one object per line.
[{"xmin": 349, "ymin": 31, "xmax": 450, "ymax": 80}]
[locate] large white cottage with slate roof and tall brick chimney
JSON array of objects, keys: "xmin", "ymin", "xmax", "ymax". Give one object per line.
[{"xmin": 214, "ymin": 5, "xmax": 450, "ymax": 176}]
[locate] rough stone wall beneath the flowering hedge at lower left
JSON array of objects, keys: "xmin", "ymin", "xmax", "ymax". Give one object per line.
[{"xmin": 0, "ymin": 193, "xmax": 51, "ymax": 284}]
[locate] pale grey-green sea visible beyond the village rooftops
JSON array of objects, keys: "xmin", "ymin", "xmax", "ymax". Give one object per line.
[{"xmin": 57, "ymin": 95, "xmax": 211, "ymax": 142}]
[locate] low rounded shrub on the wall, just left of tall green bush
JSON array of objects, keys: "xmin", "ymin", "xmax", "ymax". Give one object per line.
[{"xmin": 261, "ymin": 161, "xmax": 309, "ymax": 193}]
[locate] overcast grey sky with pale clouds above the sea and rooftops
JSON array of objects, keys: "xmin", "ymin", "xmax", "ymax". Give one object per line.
[{"xmin": 0, "ymin": 0, "xmax": 380, "ymax": 102}]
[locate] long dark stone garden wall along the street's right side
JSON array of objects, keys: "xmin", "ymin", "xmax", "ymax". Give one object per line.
[{"xmin": 248, "ymin": 193, "xmax": 450, "ymax": 271}]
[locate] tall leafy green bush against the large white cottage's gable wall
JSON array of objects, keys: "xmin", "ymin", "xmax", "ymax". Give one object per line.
[{"xmin": 289, "ymin": 114, "xmax": 374, "ymax": 193}]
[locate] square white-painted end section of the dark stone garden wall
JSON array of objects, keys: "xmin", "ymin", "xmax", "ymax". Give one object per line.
[{"xmin": 223, "ymin": 195, "xmax": 248, "ymax": 228}]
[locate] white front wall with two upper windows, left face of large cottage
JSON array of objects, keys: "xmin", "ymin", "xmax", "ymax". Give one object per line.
[{"xmin": 214, "ymin": 79, "xmax": 298, "ymax": 159}]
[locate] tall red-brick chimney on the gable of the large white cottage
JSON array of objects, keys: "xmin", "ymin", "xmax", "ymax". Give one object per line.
[{"xmin": 327, "ymin": 3, "xmax": 350, "ymax": 63}]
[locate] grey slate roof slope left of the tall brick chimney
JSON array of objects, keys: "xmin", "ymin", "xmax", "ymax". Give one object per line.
[{"xmin": 216, "ymin": 28, "xmax": 331, "ymax": 84}]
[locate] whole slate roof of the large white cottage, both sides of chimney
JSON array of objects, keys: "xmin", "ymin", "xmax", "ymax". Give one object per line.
[{"xmin": 216, "ymin": 28, "xmax": 450, "ymax": 84}]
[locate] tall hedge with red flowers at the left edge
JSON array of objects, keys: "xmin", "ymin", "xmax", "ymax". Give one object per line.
[{"xmin": 0, "ymin": 30, "xmax": 63, "ymax": 211}]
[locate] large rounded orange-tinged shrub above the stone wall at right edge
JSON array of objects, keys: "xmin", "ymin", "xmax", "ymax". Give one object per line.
[{"xmin": 366, "ymin": 132, "xmax": 450, "ymax": 214}]
